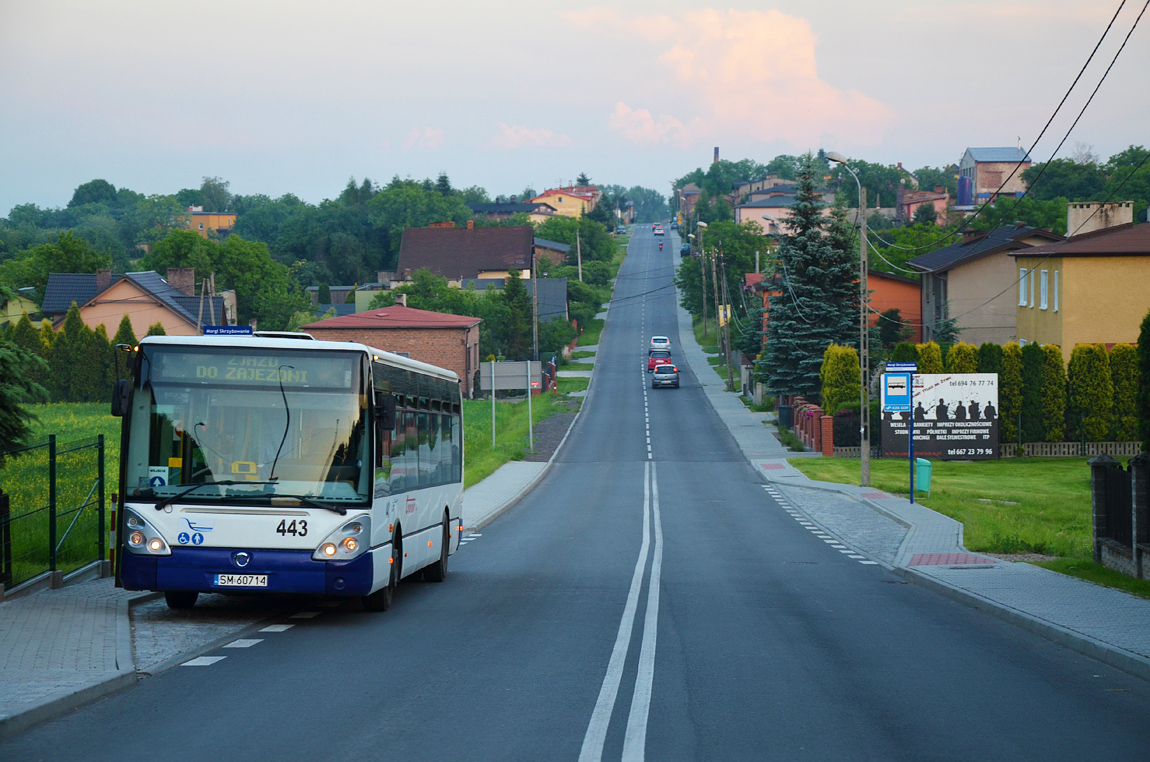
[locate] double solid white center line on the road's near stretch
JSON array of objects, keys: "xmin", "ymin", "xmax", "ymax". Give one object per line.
[{"xmin": 578, "ymin": 461, "xmax": 662, "ymax": 762}]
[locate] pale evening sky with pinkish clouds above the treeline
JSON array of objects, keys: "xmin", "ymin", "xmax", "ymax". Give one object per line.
[{"xmin": 0, "ymin": 0, "xmax": 1150, "ymax": 216}]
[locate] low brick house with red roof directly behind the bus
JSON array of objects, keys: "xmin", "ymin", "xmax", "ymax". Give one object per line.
[{"xmin": 300, "ymin": 294, "xmax": 481, "ymax": 398}]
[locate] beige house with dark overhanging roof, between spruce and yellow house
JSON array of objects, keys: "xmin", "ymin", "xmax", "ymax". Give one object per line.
[{"xmin": 907, "ymin": 223, "xmax": 1063, "ymax": 345}]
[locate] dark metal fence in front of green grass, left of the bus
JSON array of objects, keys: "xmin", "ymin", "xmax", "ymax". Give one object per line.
[{"xmin": 0, "ymin": 434, "xmax": 107, "ymax": 587}]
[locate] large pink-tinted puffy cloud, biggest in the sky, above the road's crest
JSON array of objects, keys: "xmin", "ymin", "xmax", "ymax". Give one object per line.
[{"xmin": 560, "ymin": 8, "xmax": 892, "ymax": 147}]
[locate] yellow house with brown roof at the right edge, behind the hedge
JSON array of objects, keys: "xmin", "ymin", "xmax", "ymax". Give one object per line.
[{"xmin": 1010, "ymin": 224, "xmax": 1150, "ymax": 362}]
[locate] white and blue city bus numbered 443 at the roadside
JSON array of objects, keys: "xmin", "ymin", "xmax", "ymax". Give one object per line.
[{"xmin": 112, "ymin": 334, "xmax": 463, "ymax": 611}]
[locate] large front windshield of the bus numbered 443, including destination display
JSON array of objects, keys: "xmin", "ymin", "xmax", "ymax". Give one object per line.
[{"xmin": 125, "ymin": 345, "xmax": 370, "ymax": 503}]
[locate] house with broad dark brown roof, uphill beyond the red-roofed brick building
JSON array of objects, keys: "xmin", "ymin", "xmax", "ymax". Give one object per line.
[{"xmin": 398, "ymin": 224, "xmax": 535, "ymax": 287}]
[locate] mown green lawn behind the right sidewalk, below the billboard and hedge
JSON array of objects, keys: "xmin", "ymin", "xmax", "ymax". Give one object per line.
[{"xmin": 790, "ymin": 457, "xmax": 1150, "ymax": 598}]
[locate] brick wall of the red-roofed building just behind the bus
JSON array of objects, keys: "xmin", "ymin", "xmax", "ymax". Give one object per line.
[{"xmin": 308, "ymin": 325, "xmax": 480, "ymax": 398}]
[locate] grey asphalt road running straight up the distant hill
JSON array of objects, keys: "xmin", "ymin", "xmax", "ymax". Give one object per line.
[{"xmin": 0, "ymin": 230, "xmax": 1150, "ymax": 761}]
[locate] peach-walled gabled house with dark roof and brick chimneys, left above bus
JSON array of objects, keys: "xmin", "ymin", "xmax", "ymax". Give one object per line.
[{"xmin": 43, "ymin": 268, "xmax": 236, "ymax": 338}]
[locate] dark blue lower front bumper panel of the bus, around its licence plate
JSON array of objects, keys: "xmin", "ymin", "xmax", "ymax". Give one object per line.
[{"xmin": 120, "ymin": 548, "xmax": 373, "ymax": 595}]
